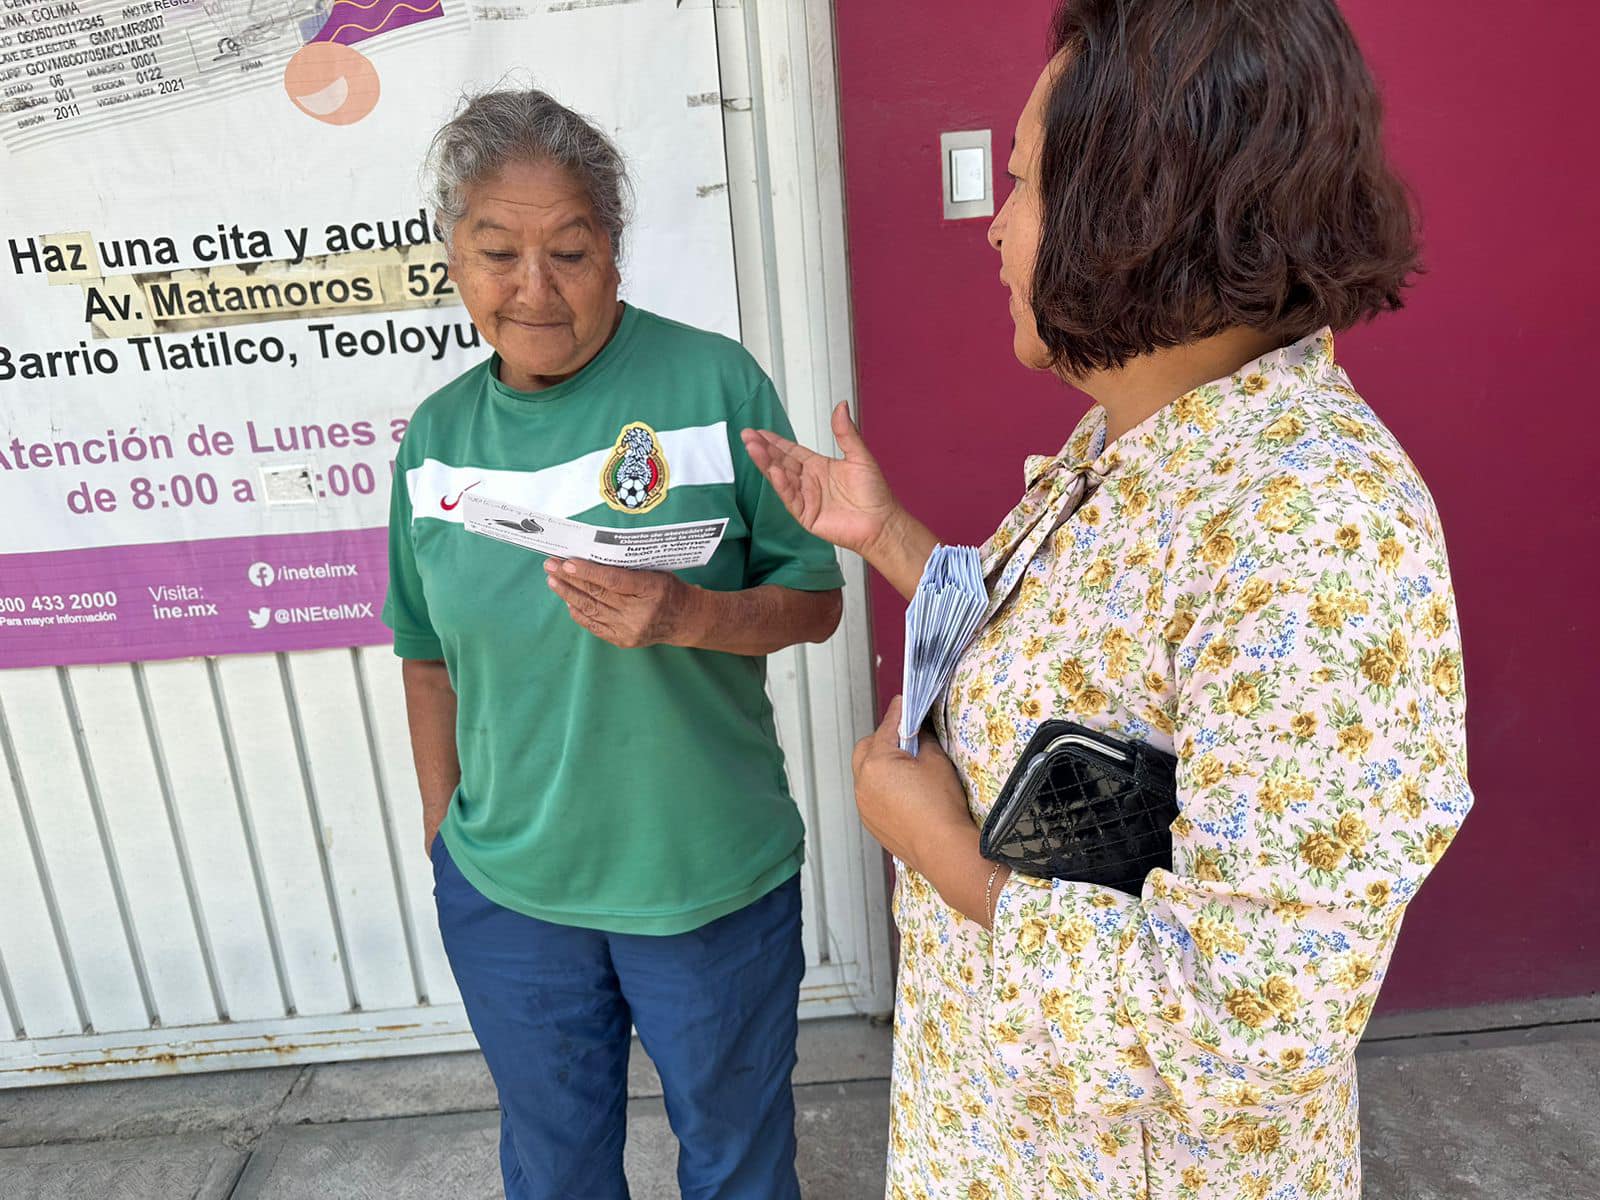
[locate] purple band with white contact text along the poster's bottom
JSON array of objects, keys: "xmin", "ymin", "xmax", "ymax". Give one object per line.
[{"xmin": 0, "ymin": 528, "xmax": 390, "ymax": 669}]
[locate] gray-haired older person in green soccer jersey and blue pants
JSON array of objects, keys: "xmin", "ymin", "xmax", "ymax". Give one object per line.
[{"xmin": 384, "ymin": 91, "xmax": 843, "ymax": 1200}]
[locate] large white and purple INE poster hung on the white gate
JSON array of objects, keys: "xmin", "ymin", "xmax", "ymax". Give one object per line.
[{"xmin": 0, "ymin": 0, "xmax": 738, "ymax": 667}]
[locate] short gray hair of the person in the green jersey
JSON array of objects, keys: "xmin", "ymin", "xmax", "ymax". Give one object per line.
[{"xmin": 422, "ymin": 88, "xmax": 634, "ymax": 261}]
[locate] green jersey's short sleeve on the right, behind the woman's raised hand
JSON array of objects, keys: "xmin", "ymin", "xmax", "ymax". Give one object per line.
[{"xmin": 728, "ymin": 376, "xmax": 845, "ymax": 592}]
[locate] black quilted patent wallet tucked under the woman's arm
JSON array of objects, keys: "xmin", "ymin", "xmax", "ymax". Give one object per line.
[{"xmin": 979, "ymin": 720, "xmax": 1178, "ymax": 896}]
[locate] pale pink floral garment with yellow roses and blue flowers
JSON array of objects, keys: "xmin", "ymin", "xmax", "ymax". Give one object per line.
[{"xmin": 888, "ymin": 331, "xmax": 1472, "ymax": 1200}]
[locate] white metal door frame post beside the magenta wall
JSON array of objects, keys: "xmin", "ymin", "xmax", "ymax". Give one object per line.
[{"xmin": 714, "ymin": 0, "xmax": 894, "ymax": 1018}]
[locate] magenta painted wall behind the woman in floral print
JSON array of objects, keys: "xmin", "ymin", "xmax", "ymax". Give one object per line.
[{"xmin": 837, "ymin": 0, "xmax": 1600, "ymax": 1010}]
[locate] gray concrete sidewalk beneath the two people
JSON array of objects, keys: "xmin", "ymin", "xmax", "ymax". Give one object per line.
[{"xmin": 0, "ymin": 997, "xmax": 1600, "ymax": 1200}]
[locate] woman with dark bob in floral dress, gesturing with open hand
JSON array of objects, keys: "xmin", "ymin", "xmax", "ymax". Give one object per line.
[{"xmin": 747, "ymin": 0, "xmax": 1470, "ymax": 1200}]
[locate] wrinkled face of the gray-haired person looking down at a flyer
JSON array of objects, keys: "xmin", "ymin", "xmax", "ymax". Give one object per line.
[{"xmin": 450, "ymin": 163, "xmax": 621, "ymax": 392}]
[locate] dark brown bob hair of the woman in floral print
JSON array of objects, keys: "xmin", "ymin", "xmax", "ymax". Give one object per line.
[{"xmin": 1034, "ymin": 0, "xmax": 1418, "ymax": 376}]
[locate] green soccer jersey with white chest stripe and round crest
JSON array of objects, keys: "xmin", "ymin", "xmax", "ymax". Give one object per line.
[{"xmin": 384, "ymin": 306, "xmax": 843, "ymax": 934}]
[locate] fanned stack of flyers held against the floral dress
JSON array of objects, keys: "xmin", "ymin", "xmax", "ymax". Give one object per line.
[{"xmin": 899, "ymin": 546, "xmax": 989, "ymax": 754}]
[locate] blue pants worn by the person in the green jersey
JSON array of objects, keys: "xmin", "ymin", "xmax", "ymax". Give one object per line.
[{"xmin": 434, "ymin": 838, "xmax": 805, "ymax": 1200}]
